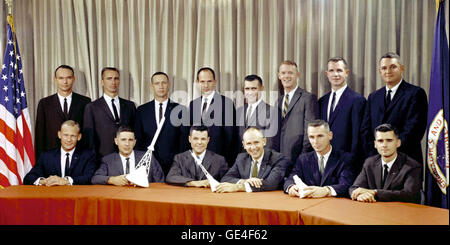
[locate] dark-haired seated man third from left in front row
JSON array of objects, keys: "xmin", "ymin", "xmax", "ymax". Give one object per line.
[{"xmin": 166, "ymin": 125, "xmax": 228, "ymax": 187}]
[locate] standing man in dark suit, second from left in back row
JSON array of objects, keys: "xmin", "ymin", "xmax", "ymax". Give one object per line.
[{"xmin": 83, "ymin": 67, "xmax": 136, "ymax": 162}]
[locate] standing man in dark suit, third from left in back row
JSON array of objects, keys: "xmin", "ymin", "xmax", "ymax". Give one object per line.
[{"xmin": 134, "ymin": 72, "xmax": 187, "ymax": 176}]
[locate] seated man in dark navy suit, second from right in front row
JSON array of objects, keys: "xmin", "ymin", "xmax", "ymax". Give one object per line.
[{"xmin": 284, "ymin": 120, "xmax": 354, "ymax": 198}]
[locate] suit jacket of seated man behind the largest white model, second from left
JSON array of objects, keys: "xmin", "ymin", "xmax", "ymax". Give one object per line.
[{"xmin": 91, "ymin": 150, "xmax": 164, "ymax": 185}]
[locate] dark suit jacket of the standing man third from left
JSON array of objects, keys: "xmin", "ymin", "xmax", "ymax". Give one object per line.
[{"xmin": 134, "ymin": 100, "xmax": 187, "ymax": 175}]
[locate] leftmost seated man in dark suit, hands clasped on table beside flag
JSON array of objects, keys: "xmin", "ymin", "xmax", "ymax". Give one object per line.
[{"xmin": 23, "ymin": 120, "xmax": 96, "ymax": 186}]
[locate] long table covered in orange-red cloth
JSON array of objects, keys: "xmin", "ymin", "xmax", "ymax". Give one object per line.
[{"xmin": 0, "ymin": 183, "xmax": 449, "ymax": 225}]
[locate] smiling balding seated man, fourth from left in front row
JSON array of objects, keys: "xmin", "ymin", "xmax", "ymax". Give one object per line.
[{"xmin": 216, "ymin": 127, "xmax": 289, "ymax": 193}]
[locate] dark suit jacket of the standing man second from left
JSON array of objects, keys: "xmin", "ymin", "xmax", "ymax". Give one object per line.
[{"xmin": 83, "ymin": 96, "xmax": 136, "ymax": 159}]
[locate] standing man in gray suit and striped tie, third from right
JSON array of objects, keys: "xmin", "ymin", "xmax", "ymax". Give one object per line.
[{"xmin": 278, "ymin": 60, "xmax": 319, "ymax": 166}]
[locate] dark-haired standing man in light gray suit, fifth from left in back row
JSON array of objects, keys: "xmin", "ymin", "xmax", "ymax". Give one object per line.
[{"xmin": 236, "ymin": 75, "xmax": 281, "ymax": 152}]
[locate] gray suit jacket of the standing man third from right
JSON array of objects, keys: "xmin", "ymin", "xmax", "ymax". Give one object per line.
[{"xmin": 278, "ymin": 87, "xmax": 319, "ymax": 162}]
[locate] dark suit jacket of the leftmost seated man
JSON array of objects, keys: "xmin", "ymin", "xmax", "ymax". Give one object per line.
[{"xmin": 23, "ymin": 147, "xmax": 96, "ymax": 185}]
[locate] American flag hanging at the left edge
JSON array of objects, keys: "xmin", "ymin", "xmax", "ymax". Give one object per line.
[{"xmin": 0, "ymin": 15, "xmax": 34, "ymax": 186}]
